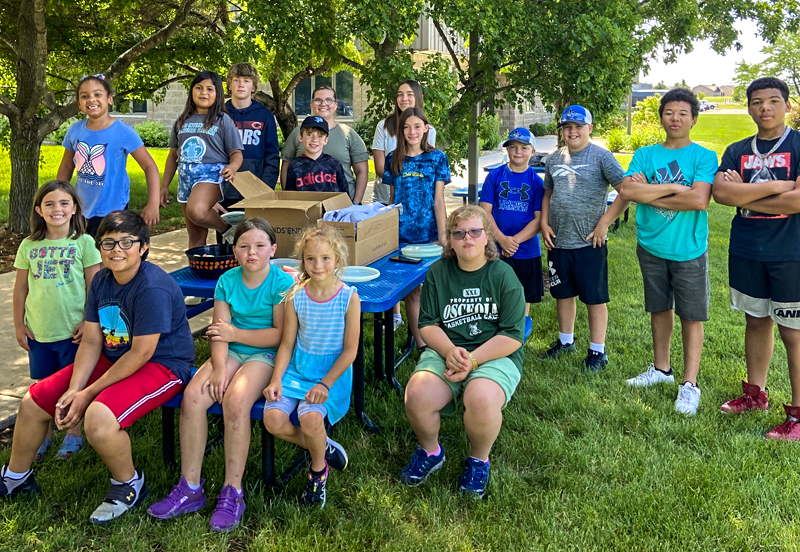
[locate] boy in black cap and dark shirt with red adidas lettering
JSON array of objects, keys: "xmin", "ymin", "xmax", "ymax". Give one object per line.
[{"xmin": 286, "ymin": 115, "xmax": 347, "ymax": 193}]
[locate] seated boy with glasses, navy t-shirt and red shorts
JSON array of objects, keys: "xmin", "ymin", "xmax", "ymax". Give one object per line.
[{"xmin": 0, "ymin": 211, "xmax": 194, "ymax": 523}]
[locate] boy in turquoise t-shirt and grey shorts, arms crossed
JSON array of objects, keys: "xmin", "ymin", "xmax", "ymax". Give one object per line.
[{"xmin": 620, "ymin": 88, "xmax": 717, "ymax": 415}]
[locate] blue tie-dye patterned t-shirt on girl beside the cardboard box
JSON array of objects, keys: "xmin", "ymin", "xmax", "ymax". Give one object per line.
[{"xmin": 383, "ymin": 150, "xmax": 450, "ymax": 243}]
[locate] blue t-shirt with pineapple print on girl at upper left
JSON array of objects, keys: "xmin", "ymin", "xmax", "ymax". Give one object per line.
[{"xmin": 61, "ymin": 120, "xmax": 144, "ymax": 218}]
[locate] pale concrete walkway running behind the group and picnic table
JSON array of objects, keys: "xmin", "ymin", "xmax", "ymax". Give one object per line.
[{"xmin": 0, "ymin": 142, "xmax": 556, "ymax": 431}]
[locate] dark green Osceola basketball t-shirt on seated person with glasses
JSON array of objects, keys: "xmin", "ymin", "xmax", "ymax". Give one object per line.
[{"xmin": 419, "ymin": 257, "xmax": 525, "ymax": 373}]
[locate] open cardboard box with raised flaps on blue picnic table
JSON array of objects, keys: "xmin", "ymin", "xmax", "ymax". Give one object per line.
[{"xmin": 232, "ymin": 171, "xmax": 399, "ymax": 266}]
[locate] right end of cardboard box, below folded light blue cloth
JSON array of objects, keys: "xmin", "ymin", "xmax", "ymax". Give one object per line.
[{"xmin": 325, "ymin": 209, "xmax": 400, "ymax": 266}]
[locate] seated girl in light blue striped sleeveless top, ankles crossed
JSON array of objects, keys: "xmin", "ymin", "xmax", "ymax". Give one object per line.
[{"xmin": 264, "ymin": 225, "xmax": 361, "ymax": 507}]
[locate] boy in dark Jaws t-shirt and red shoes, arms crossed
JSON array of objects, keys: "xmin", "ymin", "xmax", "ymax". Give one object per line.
[{"xmin": 713, "ymin": 77, "xmax": 800, "ymax": 441}]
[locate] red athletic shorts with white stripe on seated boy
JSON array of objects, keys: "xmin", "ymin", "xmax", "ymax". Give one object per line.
[{"xmin": 29, "ymin": 355, "xmax": 183, "ymax": 429}]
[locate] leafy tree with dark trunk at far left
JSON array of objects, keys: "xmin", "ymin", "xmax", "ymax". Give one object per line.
[{"xmin": 0, "ymin": 0, "xmax": 228, "ymax": 232}]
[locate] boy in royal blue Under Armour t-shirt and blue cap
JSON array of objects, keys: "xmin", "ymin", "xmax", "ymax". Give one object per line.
[{"xmin": 481, "ymin": 127, "xmax": 544, "ymax": 315}]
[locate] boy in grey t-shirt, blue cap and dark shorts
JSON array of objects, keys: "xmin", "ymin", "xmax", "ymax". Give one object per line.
[{"xmin": 539, "ymin": 105, "xmax": 629, "ymax": 373}]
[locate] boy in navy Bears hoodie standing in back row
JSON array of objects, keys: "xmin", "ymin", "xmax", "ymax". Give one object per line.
[{"xmin": 223, "ymin": 63, "xmax": 280, "ymax": 205}]
